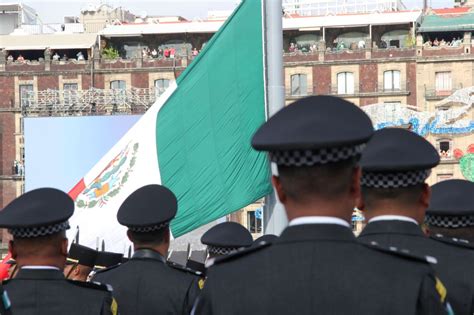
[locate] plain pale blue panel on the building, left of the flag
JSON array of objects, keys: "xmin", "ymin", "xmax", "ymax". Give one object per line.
[{"xmin": 25, "ymin": 115, "xmax": 141, "ymax": 192}]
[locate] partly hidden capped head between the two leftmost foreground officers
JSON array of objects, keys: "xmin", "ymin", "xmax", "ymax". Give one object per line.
[{"xmin": 64, "ymin": 243, "xmax": 98, "ymax": 281}]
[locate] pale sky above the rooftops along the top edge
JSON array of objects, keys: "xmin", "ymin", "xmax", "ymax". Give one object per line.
[{"xmin": 0, "ymin": 0, "xmax": 454, "ymax": 23}]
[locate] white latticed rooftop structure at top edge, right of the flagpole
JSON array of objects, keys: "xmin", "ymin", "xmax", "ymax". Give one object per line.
[{"xmin": 283, "ymin": 0, "xmax": 406, "ymax": 16}]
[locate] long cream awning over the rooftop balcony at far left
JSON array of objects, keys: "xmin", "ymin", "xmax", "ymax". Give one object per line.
[{"xmin": 0, "ymin": 34, "xmax": 97, "ymax": 51}]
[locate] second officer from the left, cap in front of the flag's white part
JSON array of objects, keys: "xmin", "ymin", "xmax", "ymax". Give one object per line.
[{"xmin": 93, "ymin": 185, "xmax": 199, "ymax": 315}]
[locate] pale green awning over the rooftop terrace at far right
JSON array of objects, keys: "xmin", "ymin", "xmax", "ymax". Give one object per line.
[{"xmin": 418, "ymin": 13, "xmax": 474, "ymax": 33}]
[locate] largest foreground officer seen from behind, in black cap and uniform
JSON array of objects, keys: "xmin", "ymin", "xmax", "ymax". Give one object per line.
[{"xmin": 194, "ymin": 96, "xmax": 446, "ymax": 315}]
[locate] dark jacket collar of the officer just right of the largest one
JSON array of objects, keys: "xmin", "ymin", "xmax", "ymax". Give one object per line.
[{"xmin": 360, "ymin": 220, "xmax": 425, "ymax": 237}]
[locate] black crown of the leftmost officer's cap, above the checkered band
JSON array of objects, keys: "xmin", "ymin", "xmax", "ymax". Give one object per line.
[{"xmin": 0, "ymin": 188, "xmax": 74, "ymax": 230}]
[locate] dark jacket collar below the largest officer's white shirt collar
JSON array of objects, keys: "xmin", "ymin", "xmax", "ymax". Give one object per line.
[{"xmin": 274, "ymin": 223, "xmax": 356, "ymax": 245}]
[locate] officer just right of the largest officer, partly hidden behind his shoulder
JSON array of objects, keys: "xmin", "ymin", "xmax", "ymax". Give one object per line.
[{"xmin": 359, "ymin": 128, "xmax": 474, "ymax": 314}]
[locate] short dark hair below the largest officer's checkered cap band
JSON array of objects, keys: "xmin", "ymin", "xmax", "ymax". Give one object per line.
[{"xmin": 278, "ymin": 158, "xmax": 357, "ymax": 200}]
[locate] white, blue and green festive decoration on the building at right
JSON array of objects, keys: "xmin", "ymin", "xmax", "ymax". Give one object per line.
[{"xmin": 362, "ymin": 87, "xmax": 474, "ymax": 181}]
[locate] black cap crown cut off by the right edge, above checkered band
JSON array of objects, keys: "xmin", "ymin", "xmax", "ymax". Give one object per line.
[{"xmin": 426, "ymin": 179, "xmax": 474, "ymax": 216}]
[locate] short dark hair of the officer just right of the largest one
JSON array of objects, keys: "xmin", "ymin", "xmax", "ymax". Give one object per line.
[{"xmin": 362, "ymin": 183, "xmax": 425, "ymax": 210}]
